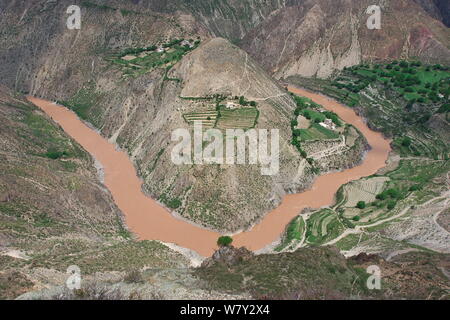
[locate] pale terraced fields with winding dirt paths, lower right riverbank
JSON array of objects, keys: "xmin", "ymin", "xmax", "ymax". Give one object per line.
[{"xmin": 277, "ymin": 159, "xmax": 450, "ymax": 255}]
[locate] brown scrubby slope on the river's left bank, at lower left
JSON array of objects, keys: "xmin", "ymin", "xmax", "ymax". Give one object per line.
[{"xmin": 0, "ymin": 86, "xmax": 188, "ymax": 299}]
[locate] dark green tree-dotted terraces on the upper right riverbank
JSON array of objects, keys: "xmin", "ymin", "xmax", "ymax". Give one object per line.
[{"xmin": 288, "ymin": 61, "xmax": 450, "ymax": 159}]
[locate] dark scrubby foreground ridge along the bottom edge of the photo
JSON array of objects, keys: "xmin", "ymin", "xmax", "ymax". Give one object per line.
[{"xmin": 13, "ymin": 247, "xmax": 450, "ymax": 300}]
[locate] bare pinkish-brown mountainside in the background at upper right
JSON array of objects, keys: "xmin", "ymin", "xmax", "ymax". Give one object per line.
[{"xmin": 241, "ymin": 0, "xmax": 450, "ymax": 78}]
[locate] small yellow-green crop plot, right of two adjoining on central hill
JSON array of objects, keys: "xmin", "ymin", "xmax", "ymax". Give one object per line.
[{"xmin": 216, "ymin": 107, "xmax": 259, "ymax": 129}]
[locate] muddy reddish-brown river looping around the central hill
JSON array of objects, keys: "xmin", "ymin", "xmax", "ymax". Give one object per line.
[{"xmin": 28, "ymin": 87, "xmax": 390, "ymax": 256}]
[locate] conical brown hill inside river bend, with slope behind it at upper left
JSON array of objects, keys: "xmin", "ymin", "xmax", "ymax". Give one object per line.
[{"xmin": 1, "ymin": 1, "xmax": 364, "ymax": 232}]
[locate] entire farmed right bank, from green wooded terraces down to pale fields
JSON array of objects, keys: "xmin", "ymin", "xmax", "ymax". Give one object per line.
[{"xmin": 280, "ymin": 62, "xmax": 450, "ymax": 257}]
